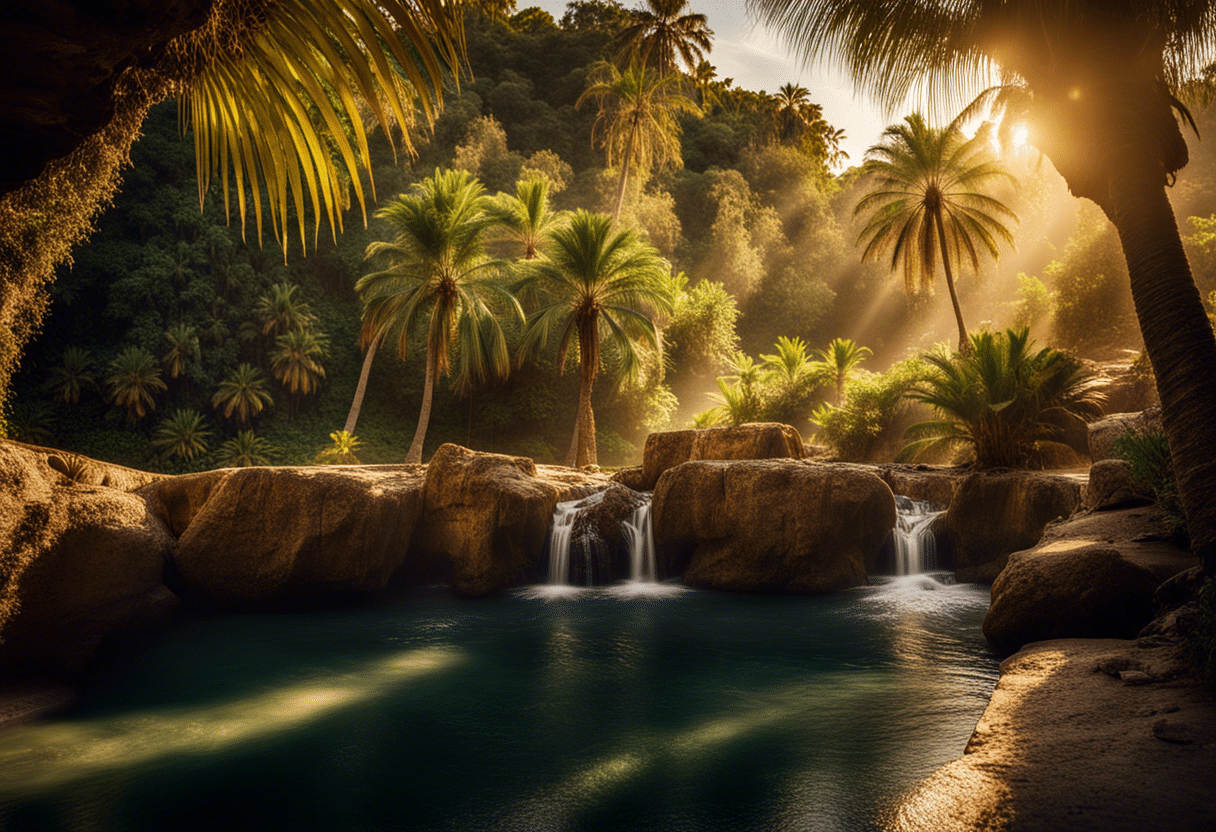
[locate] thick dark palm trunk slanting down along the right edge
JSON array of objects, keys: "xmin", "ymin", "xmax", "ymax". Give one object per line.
[{"xmin": 1103, "ymin": 169, "xmax": 1216, "ymax": 575}]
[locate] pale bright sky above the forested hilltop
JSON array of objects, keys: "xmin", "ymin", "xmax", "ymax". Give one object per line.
[{"xmin": 517, "ymin": 0, "xmax": 885, "ymax": 165}]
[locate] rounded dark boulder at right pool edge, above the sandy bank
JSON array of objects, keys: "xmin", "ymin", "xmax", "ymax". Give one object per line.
[{"xmin": 984, "ymin": 508, "xmax": 1199, "ymax": 654}]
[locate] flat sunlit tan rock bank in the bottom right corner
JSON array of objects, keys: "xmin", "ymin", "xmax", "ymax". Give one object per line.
[{"xmin": 882, "ymin": 639, "xmax": 1216, "ymax": 832}]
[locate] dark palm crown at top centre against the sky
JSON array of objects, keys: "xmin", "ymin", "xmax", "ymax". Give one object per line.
[{"xmin": 617, "ymin": 0, "xmax": 714, "ymax": 75}]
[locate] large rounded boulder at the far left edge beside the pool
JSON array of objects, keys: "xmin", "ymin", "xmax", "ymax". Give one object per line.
[{"xmin": 0, "ymin": 442, "xmax": 175, "ymax": 676}]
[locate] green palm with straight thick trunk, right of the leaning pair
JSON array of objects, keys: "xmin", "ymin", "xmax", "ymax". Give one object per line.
[{"xmin": 520, "ymin": 209, "xmax": 672, "ymax": 467}]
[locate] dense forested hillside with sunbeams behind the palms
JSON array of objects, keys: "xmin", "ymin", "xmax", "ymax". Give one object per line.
[{"xmin": 6, "ymin": 0, "xmax": 1216, "ymax": 471}]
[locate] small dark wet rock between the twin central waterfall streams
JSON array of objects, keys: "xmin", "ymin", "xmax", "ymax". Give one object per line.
[{"xmin": 561, "ymin": 484, "xmax": 647, "ymax": 586}]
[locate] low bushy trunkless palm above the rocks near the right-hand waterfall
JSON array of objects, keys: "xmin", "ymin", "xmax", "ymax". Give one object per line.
[{"xmin": 899, "ymin": 328, "xmax": 1102, "ymax": 468}]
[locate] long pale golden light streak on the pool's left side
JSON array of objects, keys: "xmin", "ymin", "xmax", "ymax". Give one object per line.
[{"xmin": 0, "ymin": 647, "xmax": 462, "ymax": 796}]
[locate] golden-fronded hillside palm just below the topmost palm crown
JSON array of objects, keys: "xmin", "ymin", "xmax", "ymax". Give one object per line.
[{"xmin": 575, "ymin": 61, "xmax": 697, "ymax": 220}]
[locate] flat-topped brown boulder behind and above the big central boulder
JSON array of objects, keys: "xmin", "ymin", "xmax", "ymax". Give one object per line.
[{"xmin": 625, "ymin": 422, "xmax": 805, "ymax": 491}]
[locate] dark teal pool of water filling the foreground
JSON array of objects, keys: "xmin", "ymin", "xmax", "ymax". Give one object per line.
[{"xmin": 0, "ymin": 575, "xmax": 996, "ymax": 831}]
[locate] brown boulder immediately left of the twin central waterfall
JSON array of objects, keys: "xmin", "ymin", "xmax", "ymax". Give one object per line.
[{"xmin": 412, "ymin": 444, "xmax": 608, "ymax": 595}]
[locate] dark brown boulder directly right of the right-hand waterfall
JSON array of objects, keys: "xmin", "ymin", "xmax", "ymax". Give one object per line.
[{"xmin": 933, "ymin": 471, "xmax": 1081, "ymax": 583}]
